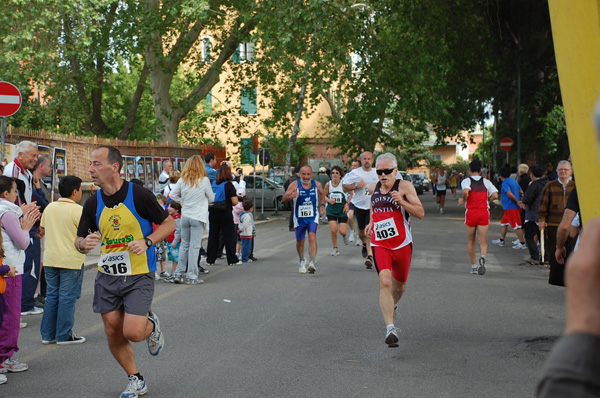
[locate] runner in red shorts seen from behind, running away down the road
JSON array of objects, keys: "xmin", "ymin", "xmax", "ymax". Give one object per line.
[{"xmin": 458, "ymin": 160, "xmax": 498, "ymax": 275}]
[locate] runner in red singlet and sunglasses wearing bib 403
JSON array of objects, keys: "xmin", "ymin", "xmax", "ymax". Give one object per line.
[{"xmin": 365, "ymin": 153, "xmax": 425, "ymax": 347}]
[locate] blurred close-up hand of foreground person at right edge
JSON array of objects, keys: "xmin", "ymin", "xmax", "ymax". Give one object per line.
[{"xmin": 565, "ymin": 217, "xmax": 600, "ymax": 336}]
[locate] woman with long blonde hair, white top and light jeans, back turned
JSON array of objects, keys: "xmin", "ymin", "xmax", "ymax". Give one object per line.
[{"xmin": 169, "ymin": 155, "xmax": 215, "ymax": 285}]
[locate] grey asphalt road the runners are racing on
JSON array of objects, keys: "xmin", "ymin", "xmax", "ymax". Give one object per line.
[{"xmin": 0, "ymin": 193, "xmax": 564, "ymax": 398}]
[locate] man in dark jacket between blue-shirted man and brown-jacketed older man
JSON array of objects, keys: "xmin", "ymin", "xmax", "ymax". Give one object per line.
[{"xmin": 521, "ymin": 164, "xmax": 548, "ymax": 264}]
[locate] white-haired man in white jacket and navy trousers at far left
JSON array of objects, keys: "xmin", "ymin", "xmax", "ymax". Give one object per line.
[{"xmin": 4, "ymin": 141, "xmax": 44, "ymax": 315}]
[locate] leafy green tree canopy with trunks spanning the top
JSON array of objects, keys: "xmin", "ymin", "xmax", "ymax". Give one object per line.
[{"xmin": 0, "ymin": 0, "xmax": 568, "ymax": 162}]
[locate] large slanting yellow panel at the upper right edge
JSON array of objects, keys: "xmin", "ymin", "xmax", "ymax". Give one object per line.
[{"xmin": 548, "ymin": 0, "xmax": 600, "ymax": 223}]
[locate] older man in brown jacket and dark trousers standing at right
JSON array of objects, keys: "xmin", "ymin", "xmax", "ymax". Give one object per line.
[{"xmin": 538, "ymin": 160, "xmax": 575, "ymax": 286}]
